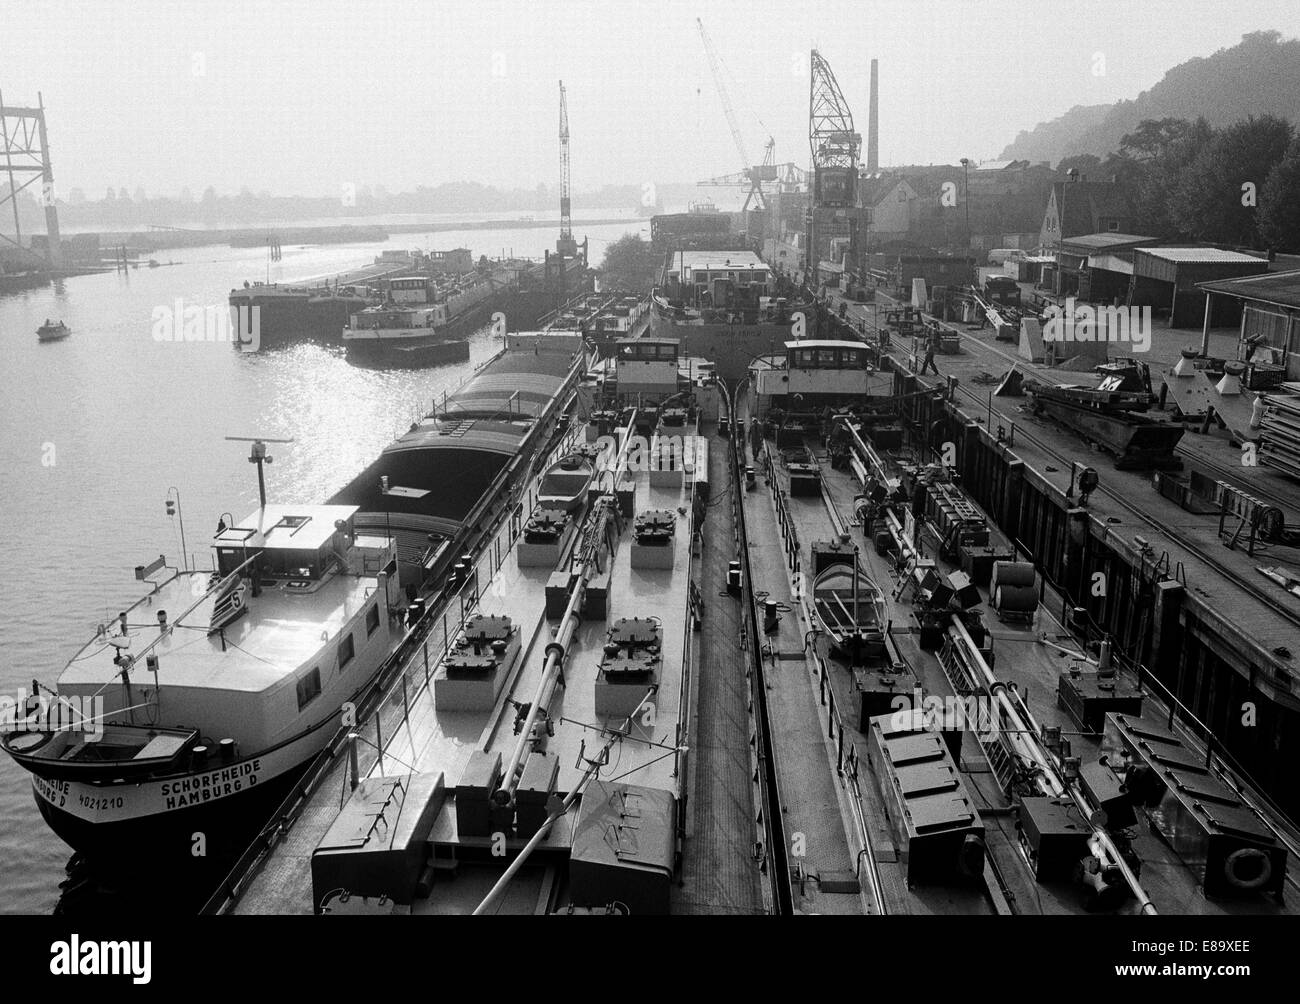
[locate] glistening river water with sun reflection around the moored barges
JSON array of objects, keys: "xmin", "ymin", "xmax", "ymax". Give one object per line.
[{"xmin": 0, "ymin": 213, "xmax": 649, "ymax": 913}]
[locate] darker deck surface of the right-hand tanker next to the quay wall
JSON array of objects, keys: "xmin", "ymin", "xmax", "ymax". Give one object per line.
[{"xmin": 746, "ymin": 387, "xmax": 1300, "ymax": 916}]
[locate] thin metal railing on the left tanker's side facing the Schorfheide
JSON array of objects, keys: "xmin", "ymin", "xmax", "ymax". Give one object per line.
[{"xmin": 200, "ymin": 413, "xmax": 590, "ymax": 914}]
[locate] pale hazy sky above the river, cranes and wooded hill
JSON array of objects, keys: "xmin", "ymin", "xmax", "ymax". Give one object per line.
[{"xmin": 0, "ymin": 0, "xmax": 1300, "ymax": 198}]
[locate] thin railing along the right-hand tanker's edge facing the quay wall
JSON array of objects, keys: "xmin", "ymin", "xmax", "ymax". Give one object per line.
[{"xmin": 1013, "ymin": 540, "xmax": 1300, "ymax": 856}]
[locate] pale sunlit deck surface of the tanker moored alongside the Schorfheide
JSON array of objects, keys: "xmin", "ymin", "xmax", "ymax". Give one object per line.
[{"xmin": 237, "ymin": 426, "xmax": 694, "ymax": 913}]
